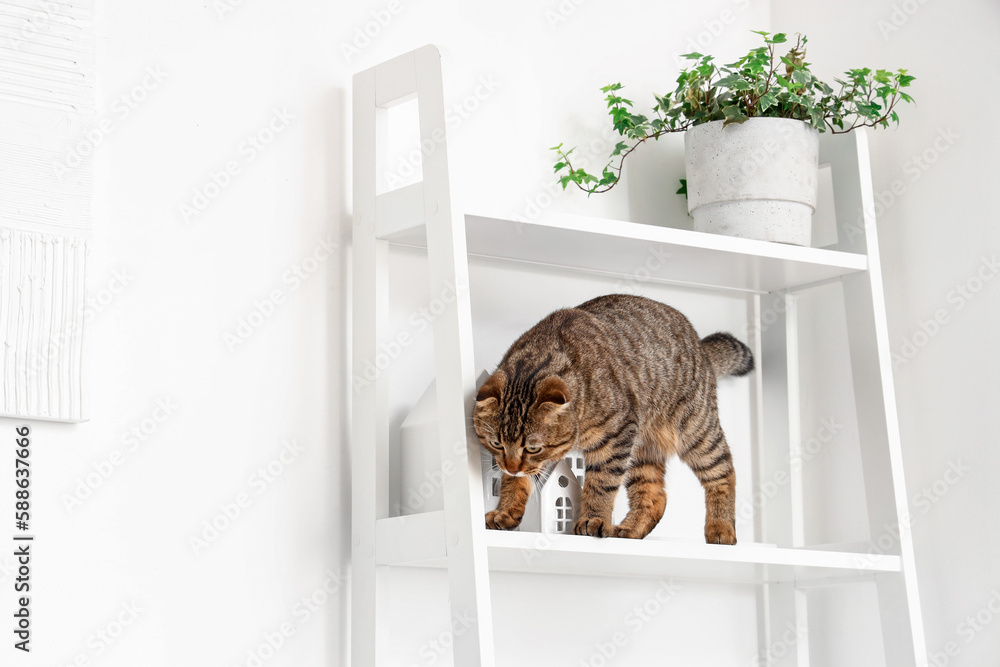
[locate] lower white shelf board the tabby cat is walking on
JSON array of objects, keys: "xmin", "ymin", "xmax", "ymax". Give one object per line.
[{"xmin": 375, "ymin": 511, "xmax": 900, "ymax": 586}]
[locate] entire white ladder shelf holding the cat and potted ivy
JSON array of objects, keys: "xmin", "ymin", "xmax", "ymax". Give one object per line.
[{"xmin": 351, "ymin": 46, "xmax": 927, "ymax": 667}]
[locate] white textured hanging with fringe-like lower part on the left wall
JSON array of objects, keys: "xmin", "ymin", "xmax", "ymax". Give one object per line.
[{"xmin": 0, "ymin": 0, "xmax": 97, "ymax": 421}]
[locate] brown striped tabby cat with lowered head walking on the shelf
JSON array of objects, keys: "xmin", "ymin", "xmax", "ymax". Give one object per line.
[{"xmin": 473, "ymin": 294, "xmax": 753, "ymax": 544}]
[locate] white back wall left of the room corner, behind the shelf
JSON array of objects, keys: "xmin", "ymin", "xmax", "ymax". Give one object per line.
[{"xmin": 0, "ymin": 0, "xmax": 767, "ymax": 666}]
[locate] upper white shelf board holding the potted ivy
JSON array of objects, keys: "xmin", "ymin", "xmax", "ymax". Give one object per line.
[{"xmin": 383, "ymin": 213, "xmax": 868, "ymax": 293}]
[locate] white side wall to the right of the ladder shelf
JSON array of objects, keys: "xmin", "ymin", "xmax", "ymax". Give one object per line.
[{"xmin": 771, "ymin": 0, "xmax": 1000, "ymax": 666}]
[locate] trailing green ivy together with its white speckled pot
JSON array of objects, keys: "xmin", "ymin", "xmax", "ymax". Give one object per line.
[{"xmin": 552, "ymin": 31, "xmax": 914, "ymax": 246}]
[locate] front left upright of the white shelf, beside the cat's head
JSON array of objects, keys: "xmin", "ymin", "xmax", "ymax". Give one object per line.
[{"xmin": 415, "ymin": 48, "xmax": 495, "ymax": 667}]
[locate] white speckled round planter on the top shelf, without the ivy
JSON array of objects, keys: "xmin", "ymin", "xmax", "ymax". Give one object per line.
[{"xmin": 684, "ymin": 118, "xmax": 819, "ymax": 246}]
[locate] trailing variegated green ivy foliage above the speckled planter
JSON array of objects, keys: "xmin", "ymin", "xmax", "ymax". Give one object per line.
[{"xmin": 552, "ymin": 30, "xmax": 914, "ymax": 194}]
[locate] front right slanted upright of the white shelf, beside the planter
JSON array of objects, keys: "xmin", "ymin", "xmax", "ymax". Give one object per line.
[{"xmin": 820, "ymin": 131, "xmax": 927, "ymax": 667}]
